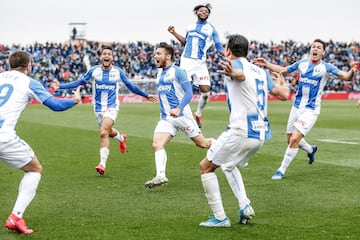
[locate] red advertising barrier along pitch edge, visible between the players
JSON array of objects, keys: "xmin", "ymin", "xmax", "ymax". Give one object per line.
[{"xmin": 30, "ymin": 92, "xmax": 360, "ymax": 104}]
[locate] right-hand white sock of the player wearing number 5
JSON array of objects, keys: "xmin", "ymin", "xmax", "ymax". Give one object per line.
[{"xmin": 223, "ymin": 167, "xmax": 250, "ymax": 209}]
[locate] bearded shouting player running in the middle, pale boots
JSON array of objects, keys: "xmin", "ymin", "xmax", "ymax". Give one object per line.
[{"xmin": 145, "ymin": 42, "xmax": 212, "ymax": 188}]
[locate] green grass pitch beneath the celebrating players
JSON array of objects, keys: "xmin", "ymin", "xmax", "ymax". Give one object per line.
[{"xmin": 0, "ymin": 101, "xmax": 360, "ymax": 240}]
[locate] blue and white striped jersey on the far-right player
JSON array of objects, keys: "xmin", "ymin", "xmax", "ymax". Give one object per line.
[{"xmin": 287, "ymin": 59, "xmax": 339, "ymax": 109}]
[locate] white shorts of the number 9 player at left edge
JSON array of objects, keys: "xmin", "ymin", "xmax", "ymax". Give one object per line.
[{"xmin": 0, "ymin": 135, "xmax": 35, "ymax": 168}]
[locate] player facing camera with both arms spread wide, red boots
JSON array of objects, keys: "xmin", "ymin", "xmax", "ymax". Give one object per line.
[{"xmin": 51, "ymin": 46, "xmax": 158, "ymax": 175}]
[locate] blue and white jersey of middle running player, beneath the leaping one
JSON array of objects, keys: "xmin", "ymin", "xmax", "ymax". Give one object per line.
[{"xmin": 156, "ymin": 64, "xmax": 192, "ymax": 119}]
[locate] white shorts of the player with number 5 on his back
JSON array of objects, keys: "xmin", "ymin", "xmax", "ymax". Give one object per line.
[{"xmin": 206, "ymin": 130, "xmax": 264, "ymax": 171}]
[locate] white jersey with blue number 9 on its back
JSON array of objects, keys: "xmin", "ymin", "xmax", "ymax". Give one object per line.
[{"xmin": 0, "ymin": 70, "xmax": 52, "ymax": 142}]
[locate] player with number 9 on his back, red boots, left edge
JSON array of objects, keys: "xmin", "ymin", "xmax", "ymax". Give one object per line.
[{"xmin": 0, "ymin": 51, "xmax": 81, "ymax": 234}]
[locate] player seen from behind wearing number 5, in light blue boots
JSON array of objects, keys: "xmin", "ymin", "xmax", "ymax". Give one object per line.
[{"xmin": 200, "ymin": 34, "xmax": 290, "ymax": 227}]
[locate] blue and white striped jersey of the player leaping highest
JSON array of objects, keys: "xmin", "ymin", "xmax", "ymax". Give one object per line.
[{"xmin": 182, "ymin": 21, "xmax": 223, "ymax": 62}]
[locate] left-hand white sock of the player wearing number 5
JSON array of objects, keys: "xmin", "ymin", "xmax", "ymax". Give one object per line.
[{"xmin": 201, "ymin": 172, "xmax": 226, "ymax": 220}]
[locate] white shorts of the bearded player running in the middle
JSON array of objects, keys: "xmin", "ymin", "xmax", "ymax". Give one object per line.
[{"xmin": 154, "ymin": 115, "xmax": 201, "ymax": 138}]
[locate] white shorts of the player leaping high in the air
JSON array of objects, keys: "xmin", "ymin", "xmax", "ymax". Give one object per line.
[{"xmin": 180, "ymin": 58, "xmax": 210, "ymax": 86}]
